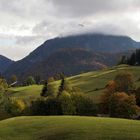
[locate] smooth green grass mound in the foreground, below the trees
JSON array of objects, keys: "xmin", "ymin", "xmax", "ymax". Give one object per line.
[{"xmin": 0, "ymin": 116, "xmax": 140, "ymax": 140}]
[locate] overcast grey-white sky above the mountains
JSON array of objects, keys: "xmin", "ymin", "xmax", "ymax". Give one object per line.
[{"xmin": 0, "ymin": 0, "xmax": 140, "ymax": 60}]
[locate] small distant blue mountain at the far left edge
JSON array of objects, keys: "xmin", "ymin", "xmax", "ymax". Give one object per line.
[{"xmin": 0, "ymin": 55, "xmax": 14, "ymax": 73}]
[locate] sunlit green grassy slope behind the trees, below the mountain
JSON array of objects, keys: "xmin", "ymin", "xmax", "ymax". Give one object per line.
[{"xmin": 9, "ymin": 66, "xmax": 140, "ymax": 101}]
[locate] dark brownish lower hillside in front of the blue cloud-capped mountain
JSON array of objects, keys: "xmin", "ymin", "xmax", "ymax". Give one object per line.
[{"xmin": 25, "ymin": 48, "xmax": 126, "ymax": 79}]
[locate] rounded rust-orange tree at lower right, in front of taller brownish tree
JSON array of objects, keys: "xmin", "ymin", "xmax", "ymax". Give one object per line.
[{"xmin": 108, "ymin": 92, "xmax": 137, "ymax": 118}]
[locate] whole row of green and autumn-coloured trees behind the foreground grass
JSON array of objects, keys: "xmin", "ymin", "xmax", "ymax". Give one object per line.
[{"xmin": 0, "ymin": 72, "xmax": 140, "ymax": 118}]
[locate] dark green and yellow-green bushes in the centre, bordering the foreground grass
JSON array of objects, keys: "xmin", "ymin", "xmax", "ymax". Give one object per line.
[{"xmin": 30, "ymin": 91, "xmax": 97, "ymax": 116}]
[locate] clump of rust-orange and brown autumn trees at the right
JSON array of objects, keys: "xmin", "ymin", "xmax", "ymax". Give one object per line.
[{"xmin": 101, "ymin": 73, "xmax": 138, "ymax": 118}]
